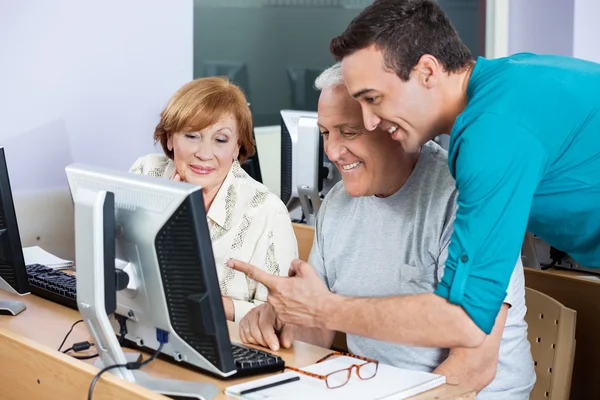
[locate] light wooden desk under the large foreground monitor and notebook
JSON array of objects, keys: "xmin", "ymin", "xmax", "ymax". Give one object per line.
[{"xmin": 0, "ymin": 291, "xmax": 475, "ymax": 400}]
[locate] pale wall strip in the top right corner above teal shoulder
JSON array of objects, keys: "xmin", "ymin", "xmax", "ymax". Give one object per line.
[{"xmin": 573, "ymin": 0, "xmax": 600, "ymax": 63}]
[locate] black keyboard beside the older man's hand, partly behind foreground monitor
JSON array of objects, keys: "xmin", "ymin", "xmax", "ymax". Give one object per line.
[{"xmin": 231, "ymin": 343, "xmax": 285, "ymax": 378}]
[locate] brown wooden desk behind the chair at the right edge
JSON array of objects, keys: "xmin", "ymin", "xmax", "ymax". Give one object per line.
[{"xmin": 525, "ymin": 268, "xmax": 600, "ymax": 399}]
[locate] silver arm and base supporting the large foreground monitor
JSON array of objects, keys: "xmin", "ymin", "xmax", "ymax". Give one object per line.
[{"xmin": 75, "ymin": 190, "xmax": 220, "ymax": 400}]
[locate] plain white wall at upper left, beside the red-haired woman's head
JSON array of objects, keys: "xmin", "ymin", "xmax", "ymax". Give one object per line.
[{"xmin": 0, "ymin": 0, "xmax": 193, "ymax": 192}]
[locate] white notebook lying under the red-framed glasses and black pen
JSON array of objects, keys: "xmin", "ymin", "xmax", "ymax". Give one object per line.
[{"xmin": 225, "ymin": 357, "xmax": 446, "ymax": 400}]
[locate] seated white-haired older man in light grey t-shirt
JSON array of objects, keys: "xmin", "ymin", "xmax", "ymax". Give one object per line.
[{"xmin": 234, "ymin": 62, "xmax": 535, "ymax": 400}]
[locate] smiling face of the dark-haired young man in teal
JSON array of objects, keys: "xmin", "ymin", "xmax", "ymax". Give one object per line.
[{"xmin": 342, "ymin": 46, "xmax": 448, "ymax": 153}]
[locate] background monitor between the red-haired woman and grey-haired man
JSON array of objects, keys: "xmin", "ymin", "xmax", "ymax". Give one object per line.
[{"xmin": 280, "ymin": 110, "xmax": 341, "ymax": 225}]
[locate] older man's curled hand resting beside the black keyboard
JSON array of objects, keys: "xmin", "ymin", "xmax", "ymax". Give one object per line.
[{"xmin": 240, "ymin": 303, "xmax": 296, "ymax": 351}]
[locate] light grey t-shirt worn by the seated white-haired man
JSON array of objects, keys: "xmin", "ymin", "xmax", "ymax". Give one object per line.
[{"xmin": 309, "ymin": 142, "xmax": 535, "ymax": 400}]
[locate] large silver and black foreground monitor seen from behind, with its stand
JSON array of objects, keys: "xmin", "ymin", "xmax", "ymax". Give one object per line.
[{"xmin": 66, "ymin": 164, "xmax": 251, "ymax": 398}]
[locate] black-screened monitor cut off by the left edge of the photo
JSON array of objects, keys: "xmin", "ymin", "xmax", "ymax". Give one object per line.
[{"xmin": 0, "ymin": 147, "xmax": 29, "ymax": 315}]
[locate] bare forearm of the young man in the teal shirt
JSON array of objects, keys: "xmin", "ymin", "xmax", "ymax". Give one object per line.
[{"xmin": 322, "ymin": 293, "xmax": 486, "ymax": 348}]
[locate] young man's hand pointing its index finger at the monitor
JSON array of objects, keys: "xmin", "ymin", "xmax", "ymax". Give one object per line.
[{"xmin": 227, "ymin": 260, "xmax": 335, "ymax": 328}]
